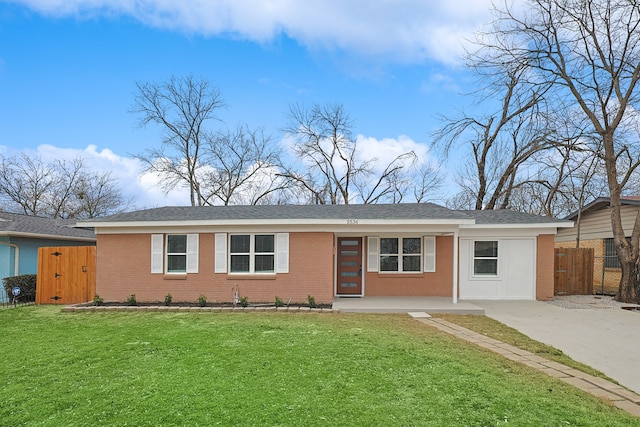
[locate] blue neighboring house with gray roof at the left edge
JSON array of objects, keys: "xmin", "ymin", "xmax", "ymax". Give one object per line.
[{"xmin": 0, "ymin": 212, "xmax": 96, "ymax": 302}]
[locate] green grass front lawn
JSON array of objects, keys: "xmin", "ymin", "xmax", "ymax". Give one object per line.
[{"xmin": 0, "ymin": 306, "xmax": 640, "ymax": 427}]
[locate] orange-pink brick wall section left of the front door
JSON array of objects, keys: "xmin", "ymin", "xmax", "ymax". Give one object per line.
[{"xmin": 96, "ymin": 233, "xmax": 333, "ymax": 303}]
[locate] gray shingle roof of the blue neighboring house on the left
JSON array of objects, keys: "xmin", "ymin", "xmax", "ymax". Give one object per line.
[{"xmin": 0, "ymin": 212, "xmax": 96, "ymax": 242}]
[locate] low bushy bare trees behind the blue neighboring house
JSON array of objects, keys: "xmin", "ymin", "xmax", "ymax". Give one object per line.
[{"xmin": 0, "ymin": 154, "xmax": 127, "ymax": 219}]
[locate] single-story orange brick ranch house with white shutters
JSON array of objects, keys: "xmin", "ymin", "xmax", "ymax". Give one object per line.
[{"xmin": 80, "ymin": 203, "xmax": 571, "ymax": 303}]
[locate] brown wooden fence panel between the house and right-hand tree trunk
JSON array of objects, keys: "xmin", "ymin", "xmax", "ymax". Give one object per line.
[{"xmin": 554, "ymin": 248, "xmax": 594, "ymax": 295}]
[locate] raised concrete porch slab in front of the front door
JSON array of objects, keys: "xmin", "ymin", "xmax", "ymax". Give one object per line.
[{"xmin": 333, "ymin": 297, "xmax": 484, "ymax": 315}]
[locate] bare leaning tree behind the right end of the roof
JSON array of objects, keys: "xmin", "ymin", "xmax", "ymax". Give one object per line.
[{"xmin": 433, "ymin": 64, "xmax": 556, "ymax": 210}]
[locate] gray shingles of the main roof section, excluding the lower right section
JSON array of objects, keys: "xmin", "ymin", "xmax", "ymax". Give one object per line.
[{"xmin": 89, "ymin": 203, "xmax": 470, "ymax": 222}]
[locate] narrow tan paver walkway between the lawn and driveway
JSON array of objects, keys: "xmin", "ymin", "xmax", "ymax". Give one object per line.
[{"xmin": 416, "ymin": 312, "xmax": 640, "ymax": 417}]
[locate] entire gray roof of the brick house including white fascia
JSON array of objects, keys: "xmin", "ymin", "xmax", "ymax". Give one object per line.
[{"xmin": 81, "ymin": 203, "xmax": 571, "ymax": 231}]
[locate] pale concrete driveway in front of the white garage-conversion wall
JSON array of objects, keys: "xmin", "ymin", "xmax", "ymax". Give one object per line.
[{"xmin": 473, "ymin": 297, "xmax": 640, "ymax": 393}]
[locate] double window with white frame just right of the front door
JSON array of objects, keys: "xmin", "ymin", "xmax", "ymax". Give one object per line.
[{"xmin": 380, "ymin": 237, "xmax": 422, "ymax": 273}]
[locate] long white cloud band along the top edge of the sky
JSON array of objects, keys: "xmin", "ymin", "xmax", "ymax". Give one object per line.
[{"xmin": 14, "ymin": 0, "xmax": 491, "ymax": 64}]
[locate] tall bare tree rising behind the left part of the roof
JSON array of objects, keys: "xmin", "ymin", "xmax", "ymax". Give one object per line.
[{"xmin": 132, "ymin": 76, "xmax": 224, "ymax": 206}]
